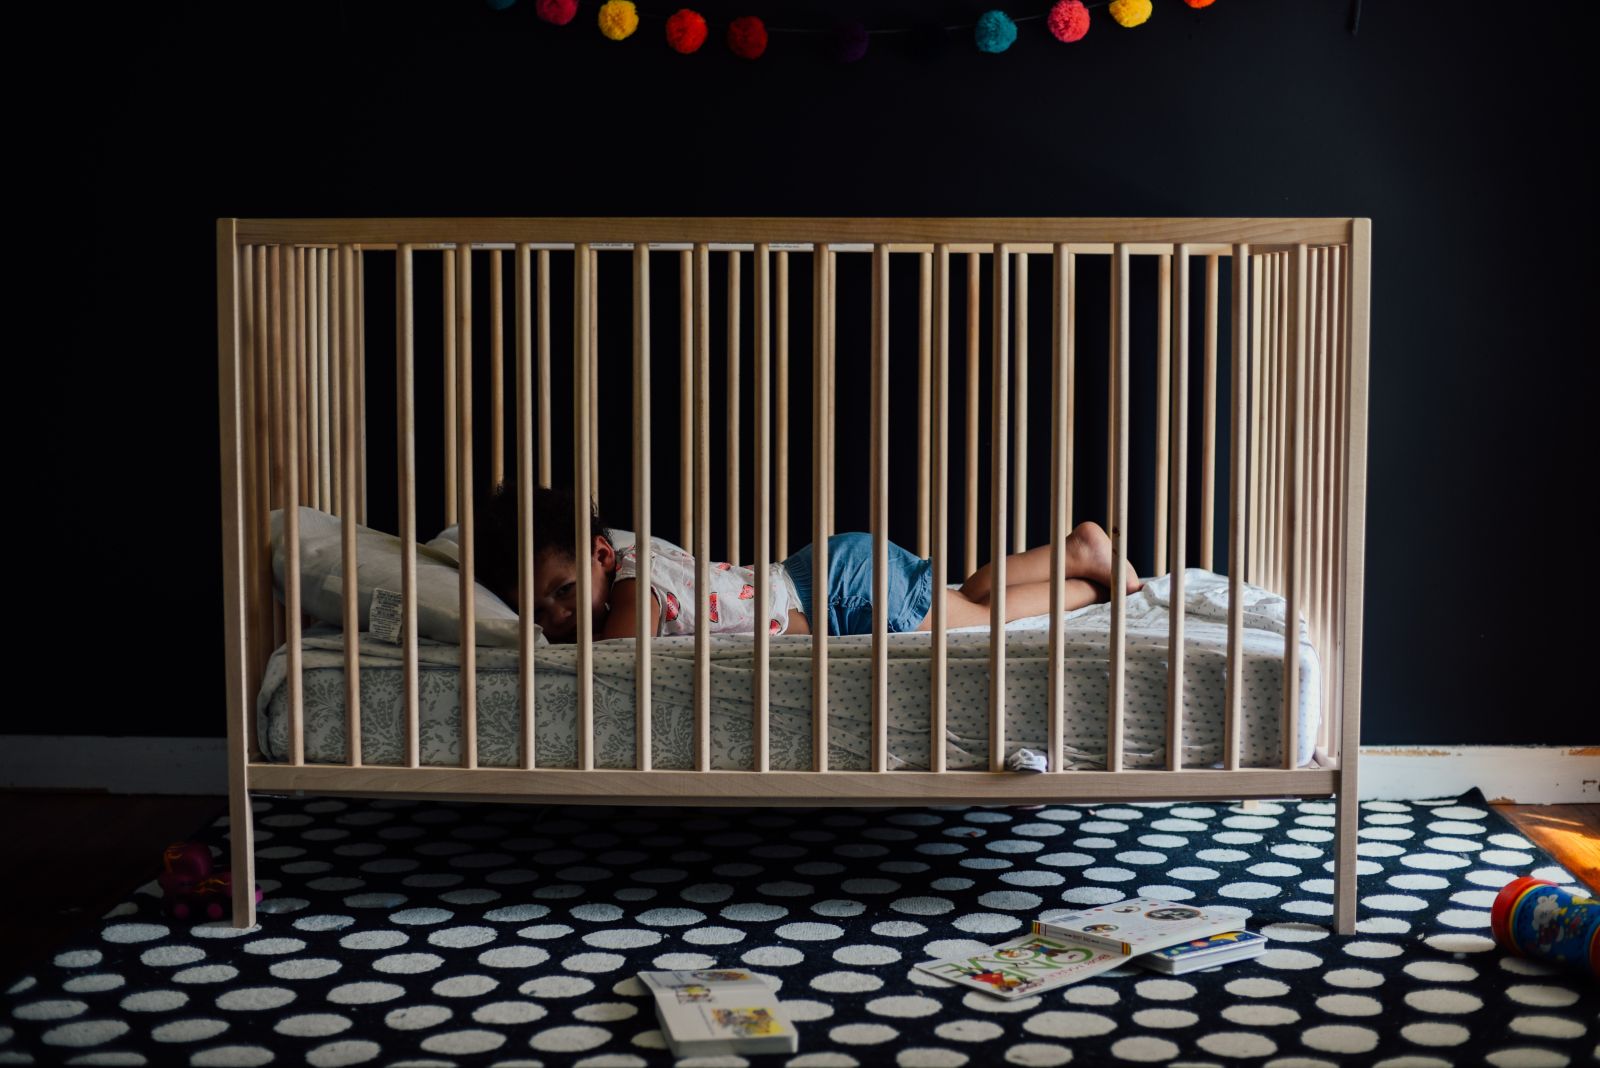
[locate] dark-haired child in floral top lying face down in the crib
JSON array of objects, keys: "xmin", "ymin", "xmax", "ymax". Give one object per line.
[{"xmin": 474, "ymin": 483, "xmax": 1144, "ymax": 641}]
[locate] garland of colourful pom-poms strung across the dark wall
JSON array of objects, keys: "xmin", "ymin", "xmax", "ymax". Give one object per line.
[{"xmin": 485, "ymin": 0, "xmax": 1222, "ymax": 62}]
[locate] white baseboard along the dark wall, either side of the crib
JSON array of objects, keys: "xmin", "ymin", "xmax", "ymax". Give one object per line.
[{"xmin": 0, "ymin": 734, "xmax": 1600, "ymax": 804}]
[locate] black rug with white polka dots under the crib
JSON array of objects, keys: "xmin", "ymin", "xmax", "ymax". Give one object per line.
[{"xmin": 0, "ymin": 791, "xmax": 1600, "ymax": 1068}]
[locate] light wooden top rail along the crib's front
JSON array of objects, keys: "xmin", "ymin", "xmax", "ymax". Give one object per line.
[{"xmin": 235, "ymin": 216, "xmax": 1355, "ymax": 254}]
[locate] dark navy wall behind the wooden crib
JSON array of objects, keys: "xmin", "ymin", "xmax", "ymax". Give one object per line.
[{"xmin": 25, "ymin": 0, "xmax": 1595, "ymax": 743}]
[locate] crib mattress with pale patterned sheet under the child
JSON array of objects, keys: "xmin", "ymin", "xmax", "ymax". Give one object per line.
[{"xmin": 256, "ymin": 569, "xmax": 1322, "ymax": 771}]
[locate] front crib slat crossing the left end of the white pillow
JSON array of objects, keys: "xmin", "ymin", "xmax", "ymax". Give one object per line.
[{"xmin": 272, "ymin": 246, "xmax": 306, "ymax": 764}]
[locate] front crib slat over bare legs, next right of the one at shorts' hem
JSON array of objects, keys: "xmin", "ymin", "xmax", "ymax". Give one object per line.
[{"xmin": 989, "ymin": 245, "xmax": 1011, "ymax": 771}]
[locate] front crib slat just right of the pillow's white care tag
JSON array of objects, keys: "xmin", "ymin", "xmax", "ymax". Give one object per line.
[{"xmin": 395, "ymin": 245, "xmax": 422, "ymax": 767}]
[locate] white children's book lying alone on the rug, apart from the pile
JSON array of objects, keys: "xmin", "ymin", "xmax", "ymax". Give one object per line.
[{"xmin": 638, "ymin": 967, "xmax": 800, "ymax": 1057}]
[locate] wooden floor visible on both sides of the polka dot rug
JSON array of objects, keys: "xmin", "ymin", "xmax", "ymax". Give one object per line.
[{"xmin": 0, "ymin": 791, "xmax": 1600, "ymax": 988}]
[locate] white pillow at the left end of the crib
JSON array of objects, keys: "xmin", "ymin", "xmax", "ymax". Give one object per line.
[{"xmin": 270, "ymin": 505, "xmax": 549, "ymax": 648}]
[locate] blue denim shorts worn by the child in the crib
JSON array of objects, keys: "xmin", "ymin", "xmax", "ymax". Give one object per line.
[{"xmin": 784, "ymin": 532, "xmax": 933, "ymax": 635}]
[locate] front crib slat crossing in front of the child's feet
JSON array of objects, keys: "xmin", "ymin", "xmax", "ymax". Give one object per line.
[{"xmin": 1106, "ymin": 243, "xmax": 1131, "ymax": 771}]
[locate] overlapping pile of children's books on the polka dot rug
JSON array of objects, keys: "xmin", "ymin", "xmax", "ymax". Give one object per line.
[{"xmin": 917, "ymin": 897, "xmax": 1266, "ymax": 999}]
